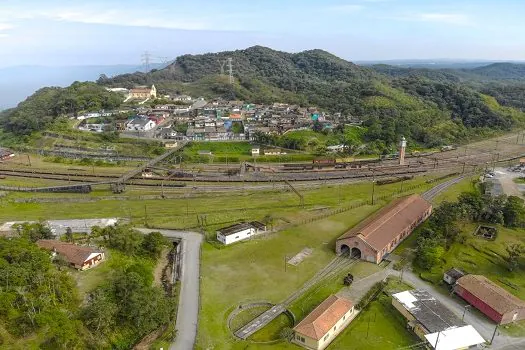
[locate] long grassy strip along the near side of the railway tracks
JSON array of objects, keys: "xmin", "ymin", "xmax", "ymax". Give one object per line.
[{"xmin": 0, "ymin": 177, "xmax": 440, "ymax": 232}]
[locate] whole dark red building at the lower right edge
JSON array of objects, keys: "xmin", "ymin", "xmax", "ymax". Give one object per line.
[{"xmin": 454, "ymin": 275, "xmax": 525, "ymax": 324}]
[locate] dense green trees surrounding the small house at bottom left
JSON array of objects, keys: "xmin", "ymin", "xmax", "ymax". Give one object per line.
[{"xmin": 0, "ymin": 223, "xmax": 176, "ymax": 350}]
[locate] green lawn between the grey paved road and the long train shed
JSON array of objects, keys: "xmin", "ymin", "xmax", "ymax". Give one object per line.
[{"xmin": 197, "ymin": 205, "xmax": 379, "ymax": 349}]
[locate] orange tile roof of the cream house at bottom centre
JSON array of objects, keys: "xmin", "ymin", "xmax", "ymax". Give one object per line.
[{"xmin": 294, "ymin": 295, "xmax": 354, "ymax": 340}]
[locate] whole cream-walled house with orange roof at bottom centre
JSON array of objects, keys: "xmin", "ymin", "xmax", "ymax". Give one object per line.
[{"xmin": 293, "ymin": 295, "xmax": 358, "ymax": 350}]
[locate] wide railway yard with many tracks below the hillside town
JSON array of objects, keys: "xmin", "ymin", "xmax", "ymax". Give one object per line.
[{"xmin": 0, "ymin": 134, "xmax": 525, "ymax": 193}]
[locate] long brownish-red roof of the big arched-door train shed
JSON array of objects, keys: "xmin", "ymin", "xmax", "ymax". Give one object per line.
[{"xmin": 338, "ymin": 194, "xmax": 432, "ymax": 251}]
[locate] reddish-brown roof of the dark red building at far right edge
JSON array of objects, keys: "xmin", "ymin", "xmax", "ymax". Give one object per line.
[{"xmin": 456, "ymin": 275, "xmax": 525, "ymax": 315}]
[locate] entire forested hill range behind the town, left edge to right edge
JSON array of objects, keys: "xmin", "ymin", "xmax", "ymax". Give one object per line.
[{"xmin": 0, "ymin": 46, "xmax": 525, "ymax": 147}]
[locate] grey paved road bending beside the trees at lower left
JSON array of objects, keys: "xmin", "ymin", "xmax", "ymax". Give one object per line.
[{"xmin": 139, "ymin": 229, "xmax": 202, "ymax": 350}]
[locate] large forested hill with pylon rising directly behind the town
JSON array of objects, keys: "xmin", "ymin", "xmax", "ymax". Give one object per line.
[{"xmin": 98, "ymin": 46, "xmax": 525, "ymax": 147}]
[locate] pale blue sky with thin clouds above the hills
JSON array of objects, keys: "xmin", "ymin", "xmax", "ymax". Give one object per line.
[{"xmin": 0, "ymin": 0, "xmax": 525, "ymax": 67}]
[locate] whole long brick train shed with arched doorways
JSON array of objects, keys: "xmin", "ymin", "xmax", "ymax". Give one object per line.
[{"xmin": 335, "ymin": 195, "xmax": 432, "ymax": 264}]
